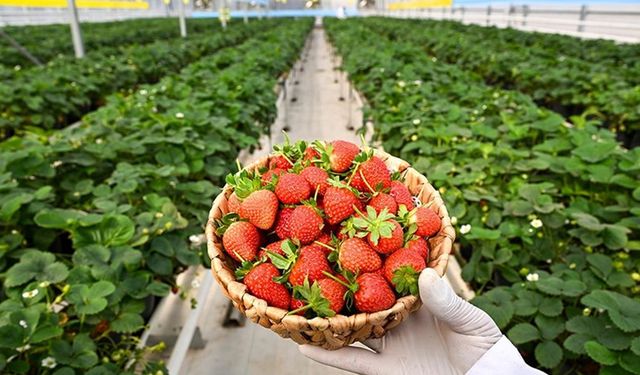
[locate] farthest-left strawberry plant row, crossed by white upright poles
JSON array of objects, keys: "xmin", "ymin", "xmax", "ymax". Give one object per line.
[{"xmin": 0, "ymin": 18, "xmax": 217, "ymax": 70}]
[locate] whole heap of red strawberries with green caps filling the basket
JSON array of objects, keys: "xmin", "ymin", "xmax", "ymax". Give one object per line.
[{"xmin": 215, "ymin": 140, "xmax": 441, "ymax": 318}]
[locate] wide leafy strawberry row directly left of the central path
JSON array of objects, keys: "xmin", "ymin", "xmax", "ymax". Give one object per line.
[{"xmin": 0, "ymin": 20, "xmax": 311, "ymax": 374}]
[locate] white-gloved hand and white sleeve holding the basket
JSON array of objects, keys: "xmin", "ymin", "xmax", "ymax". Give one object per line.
[{"xmin": 300, "ymin": 268, "xmax": 542, "ymax": 375}]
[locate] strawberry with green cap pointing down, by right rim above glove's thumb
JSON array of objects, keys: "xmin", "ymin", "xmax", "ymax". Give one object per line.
[{"xmin": 384, "ymin": 249, "xmax": 427, "ymax": 295}]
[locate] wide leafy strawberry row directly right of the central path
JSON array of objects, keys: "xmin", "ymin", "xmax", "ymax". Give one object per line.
[{"xmin": 327, "ymin": 19, "xmax": 640, "ymax": 374}]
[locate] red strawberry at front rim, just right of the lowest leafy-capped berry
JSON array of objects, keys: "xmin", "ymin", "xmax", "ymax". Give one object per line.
[{"xmin": 354, "ymin": 273, "xmax": 396, "ymax": 313}]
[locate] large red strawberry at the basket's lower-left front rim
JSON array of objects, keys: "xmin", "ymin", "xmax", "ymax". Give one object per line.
[{"xmin": 244, "ymin": 263, "xmax": 291, "ymax": 310}]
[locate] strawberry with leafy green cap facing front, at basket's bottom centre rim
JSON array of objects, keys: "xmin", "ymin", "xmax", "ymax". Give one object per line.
[{"xmin": 289, "ymin": 278, "xmax": 347, "ymax": 317}]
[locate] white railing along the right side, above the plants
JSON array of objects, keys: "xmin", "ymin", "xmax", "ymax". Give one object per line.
[{"xmin": 362, "ymin": 5, "xmax": 640, "ymax": 43}]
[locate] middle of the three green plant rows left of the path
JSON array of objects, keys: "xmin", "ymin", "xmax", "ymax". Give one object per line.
[{"xmin": 0, "ymin": 19, "xmax": 264, "ymax": 139}]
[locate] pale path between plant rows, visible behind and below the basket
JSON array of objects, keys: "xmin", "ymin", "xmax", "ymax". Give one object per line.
[{"xmin": 180, "ymin": 19, "xmax": 362, "ymax": 375}]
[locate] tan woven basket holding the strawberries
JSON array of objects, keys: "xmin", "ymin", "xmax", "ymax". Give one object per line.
[{"xmin": 206, "ymin": 151, "xmax": 455, "ymax": 350}]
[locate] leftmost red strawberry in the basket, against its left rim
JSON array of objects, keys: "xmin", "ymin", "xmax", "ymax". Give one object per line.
[{"xmin": 222, "ymin": 221, "xmax": 260, "ymax": 261}]
